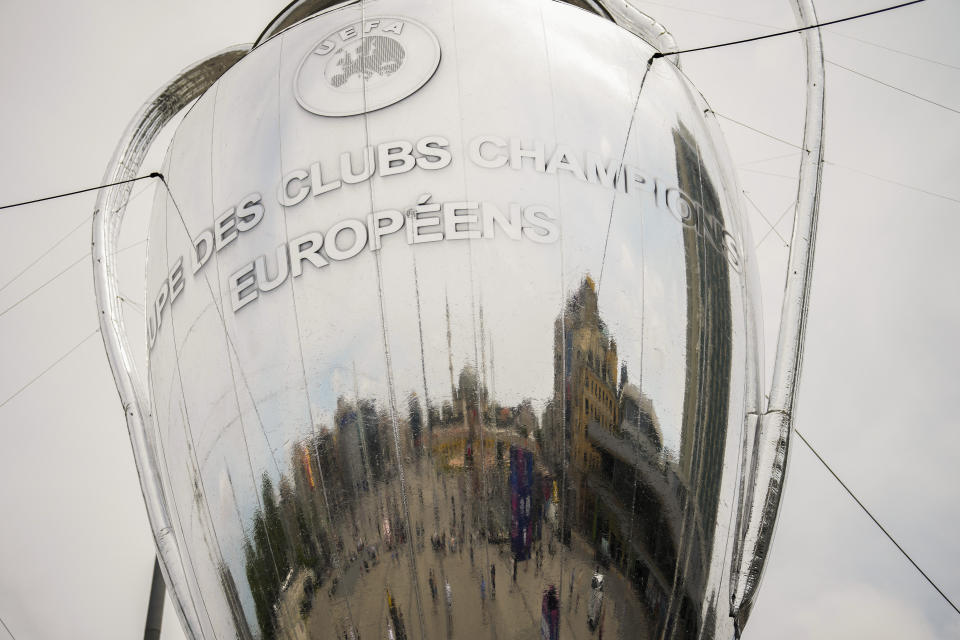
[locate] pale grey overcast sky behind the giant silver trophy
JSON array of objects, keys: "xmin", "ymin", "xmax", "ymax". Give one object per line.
[{"xmin": 0, "ymin": 0, "xmax": 960, "ymax": 640}]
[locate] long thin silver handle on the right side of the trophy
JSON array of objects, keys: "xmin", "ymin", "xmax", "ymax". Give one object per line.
[{"xmin": 730, "ymin": 0, "xmax": 824, "ymax": 637}]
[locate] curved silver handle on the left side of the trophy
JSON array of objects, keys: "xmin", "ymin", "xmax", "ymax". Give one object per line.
[{"xmin": 92, "ymin": 45, "xmax": 251, "ymax": 638}]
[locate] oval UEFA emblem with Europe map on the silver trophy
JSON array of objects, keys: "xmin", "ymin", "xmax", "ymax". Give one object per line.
[{"xmin": 294, "ymin": 16, "xmax": 440, "ymax": 116}]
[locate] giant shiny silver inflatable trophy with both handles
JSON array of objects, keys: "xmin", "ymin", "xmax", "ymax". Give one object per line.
[{"xmin": 94, "ymin": 0, "xmax": 823, "ymax": 638}]
